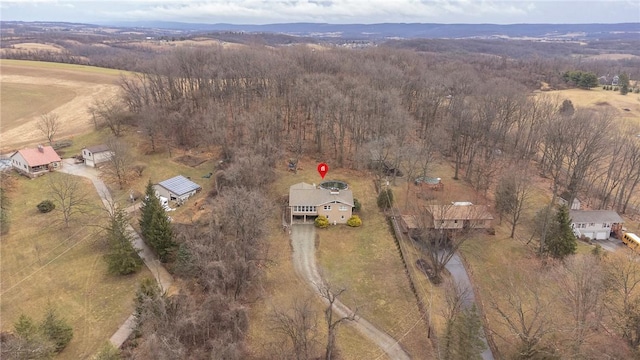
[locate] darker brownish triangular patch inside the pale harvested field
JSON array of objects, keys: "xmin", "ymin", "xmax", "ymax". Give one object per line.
[{"xmin": 0, "ymin": 82, "xmax": 76, "ymax": 131}]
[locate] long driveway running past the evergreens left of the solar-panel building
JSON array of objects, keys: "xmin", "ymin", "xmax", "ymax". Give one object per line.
[{"xmin": 60, "ymin": 159, "xmax": 173, "ymax": 348}]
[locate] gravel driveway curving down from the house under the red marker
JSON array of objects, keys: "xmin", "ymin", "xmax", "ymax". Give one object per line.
[{"xmin": 291, "ymin": 224, "xmax": 410, "ymax": 360}]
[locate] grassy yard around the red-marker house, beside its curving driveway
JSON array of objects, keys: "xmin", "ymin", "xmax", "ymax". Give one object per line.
[{"xmin": 260, "ymin": 160, "xmax": 432, "ymax": 359}]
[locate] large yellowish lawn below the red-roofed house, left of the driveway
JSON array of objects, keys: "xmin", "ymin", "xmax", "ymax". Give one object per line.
[{"xmin": 0, "ymin": 173, "xmax": 152, "ymax": 359}]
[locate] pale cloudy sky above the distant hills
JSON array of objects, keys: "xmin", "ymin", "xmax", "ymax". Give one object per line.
[{"xmin": 0, "ymin": 0, "xmax": 640, "ymax": 24}]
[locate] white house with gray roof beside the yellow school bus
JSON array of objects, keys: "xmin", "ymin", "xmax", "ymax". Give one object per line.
[{"xmin": 569, "ymin": 210, "xmax": 624, "ymax": 240}]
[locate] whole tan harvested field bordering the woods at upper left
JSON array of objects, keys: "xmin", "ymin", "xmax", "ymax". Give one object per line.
[{"xmin": 0, "ymin": 60, "xmax": 121, "ymax": 152}]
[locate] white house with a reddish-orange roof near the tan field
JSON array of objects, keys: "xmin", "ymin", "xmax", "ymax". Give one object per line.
[{"xmin": 9, "ymin": 145, "xmax": 62, "ymax": 178}]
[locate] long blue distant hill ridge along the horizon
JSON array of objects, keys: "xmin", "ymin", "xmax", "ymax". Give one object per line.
[{"xmin": 105, "ymin": 21, "xmax": 640, "ymax": 40}]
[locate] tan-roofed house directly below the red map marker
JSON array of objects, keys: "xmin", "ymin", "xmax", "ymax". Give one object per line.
[{"xmin": 289, "ymin": 183, "xmax": 354, "ymax": 224}]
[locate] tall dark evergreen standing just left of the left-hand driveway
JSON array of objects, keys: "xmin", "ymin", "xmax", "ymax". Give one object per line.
[{"xmin": 105, "ymin": 205, "xmax": 142, "ymax": 275}]
